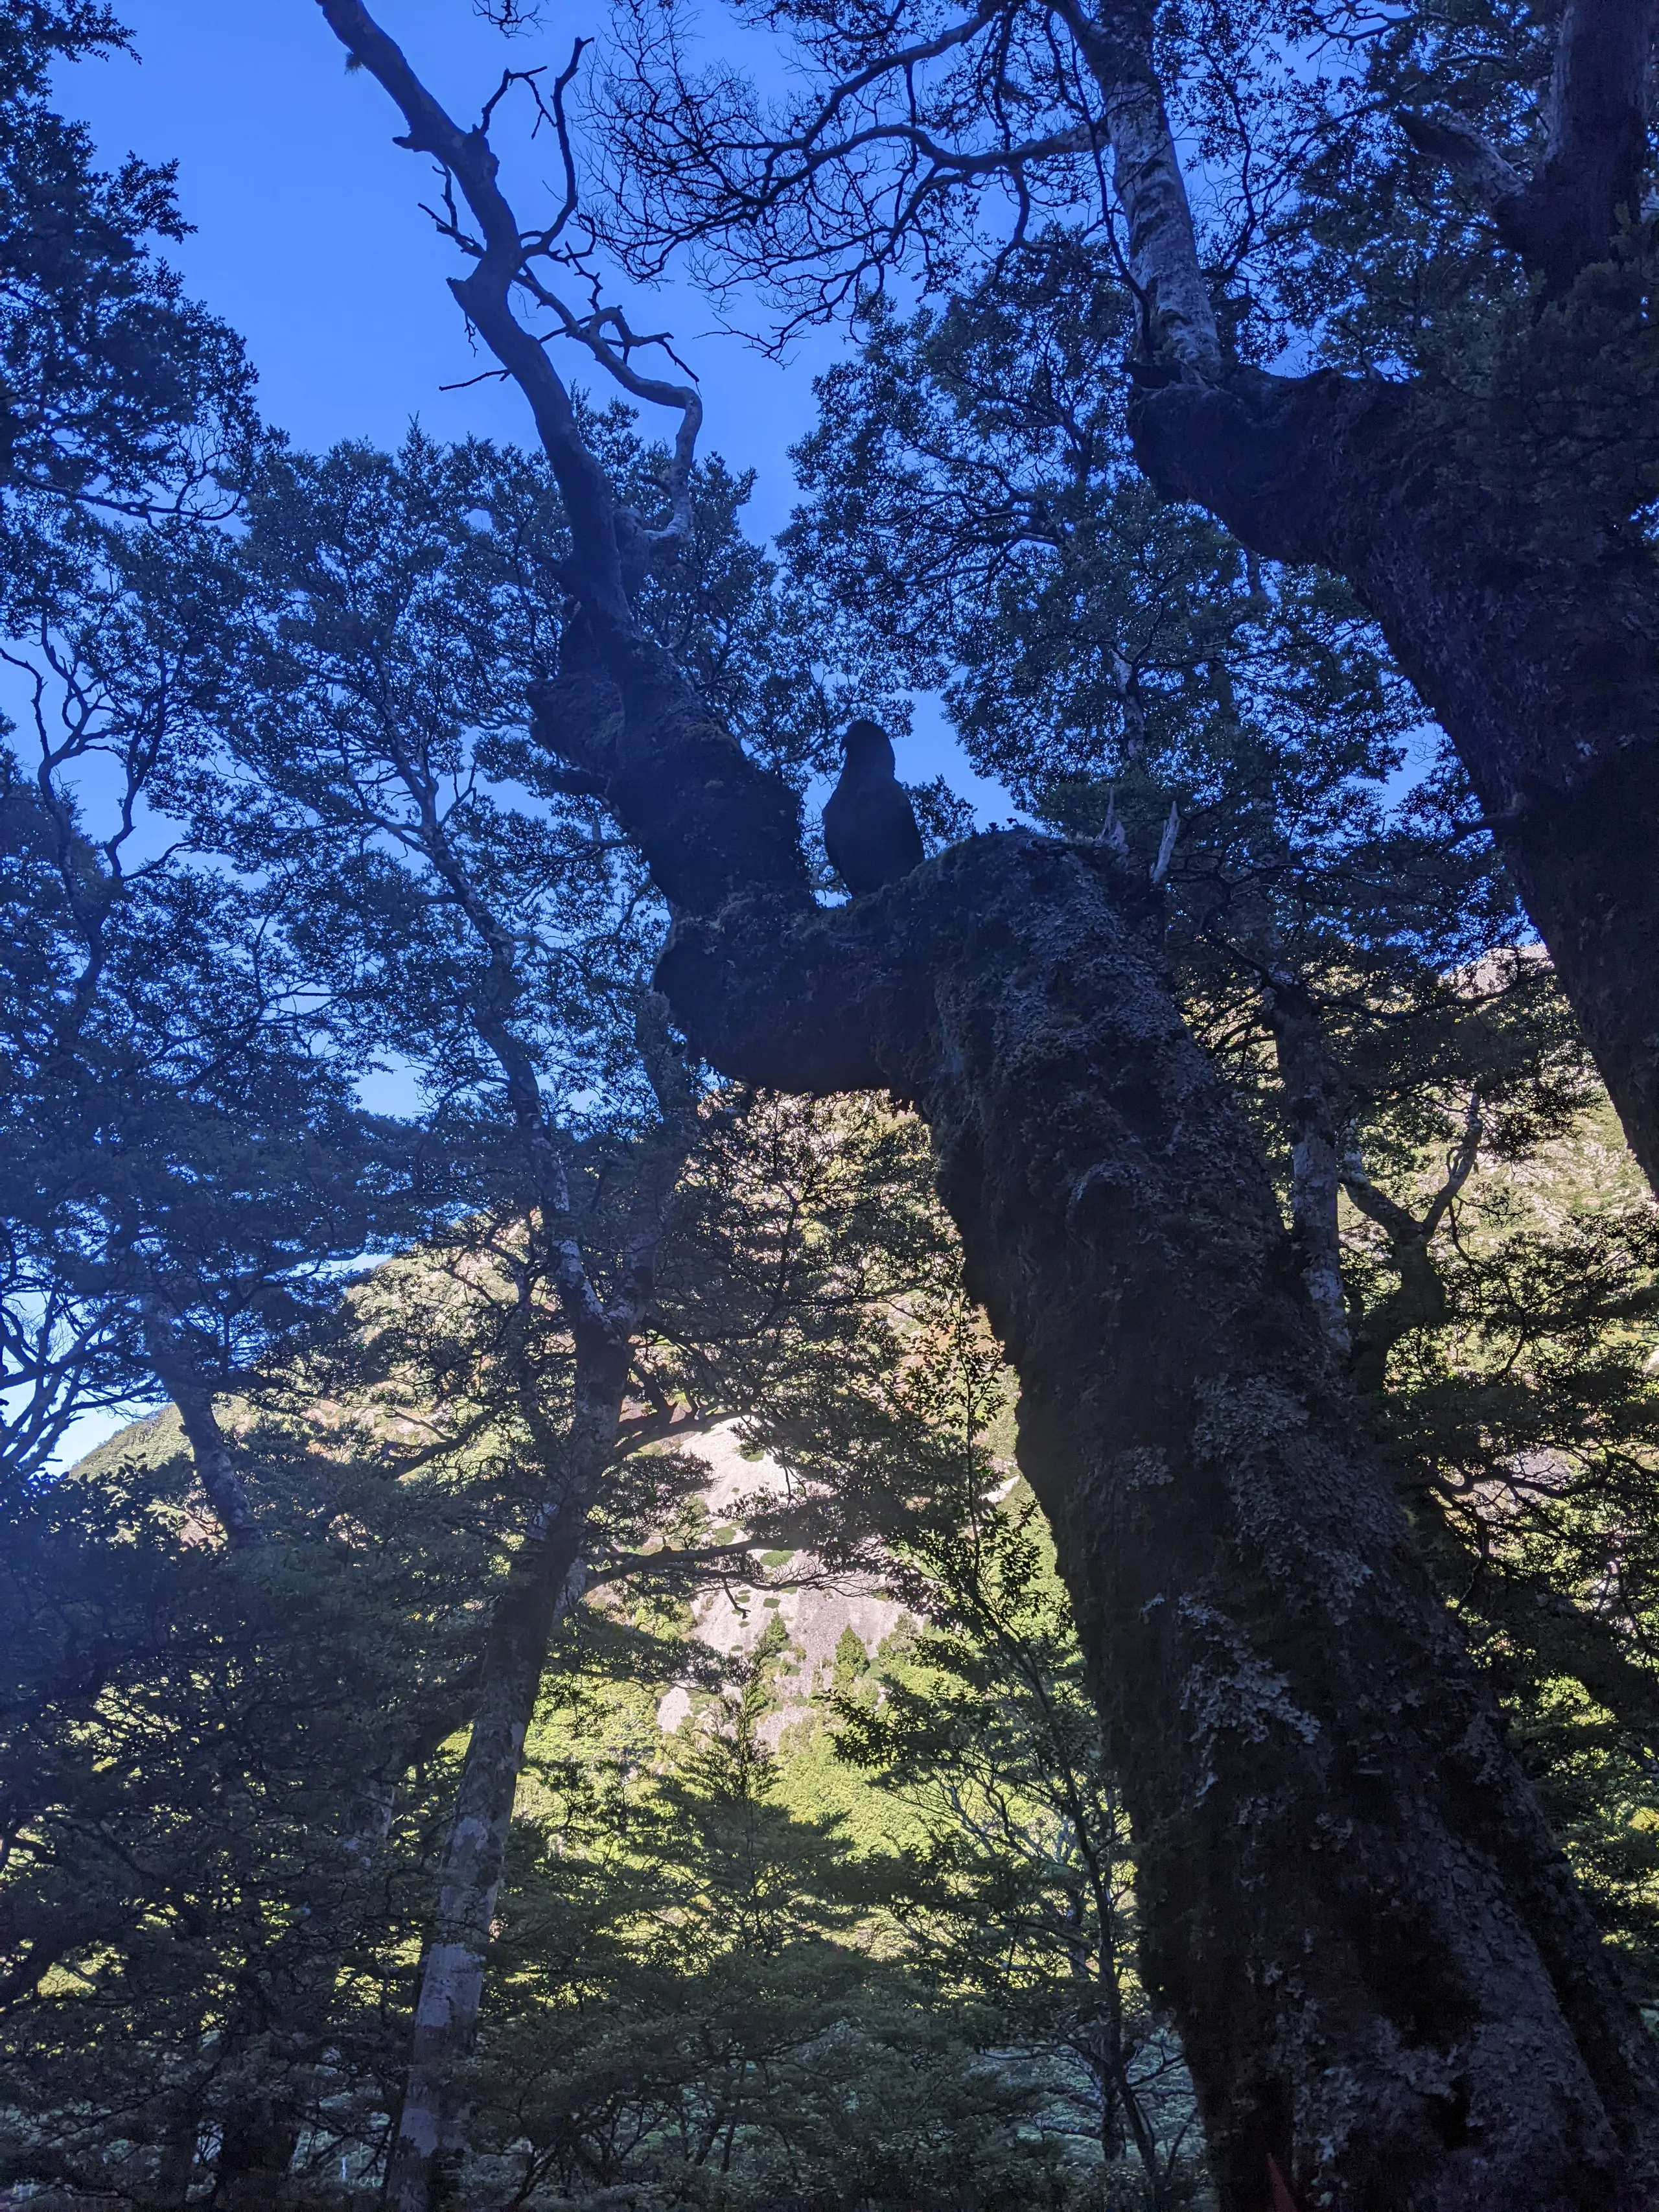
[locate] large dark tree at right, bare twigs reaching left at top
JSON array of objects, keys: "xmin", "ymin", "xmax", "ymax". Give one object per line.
[{"xmin": 597, "ymin": 0, "xmax": 1659, "ymax": 1212}]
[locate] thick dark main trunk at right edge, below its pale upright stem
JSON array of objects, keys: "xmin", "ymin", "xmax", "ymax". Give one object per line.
[{"xmin": 1135, "ymin": 369, "xmax": 1659, "ymax": 1188}]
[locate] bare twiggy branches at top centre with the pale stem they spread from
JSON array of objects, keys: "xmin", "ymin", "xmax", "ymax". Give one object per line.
[{"xmin": 610, "ymin": 0, "xmax": 1221, "ymax": 374}]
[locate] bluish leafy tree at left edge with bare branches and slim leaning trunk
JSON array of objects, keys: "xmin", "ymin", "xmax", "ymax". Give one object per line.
[{"xmin": 0, "ymin": 533, "xmax": 429, "ymax": 1513}]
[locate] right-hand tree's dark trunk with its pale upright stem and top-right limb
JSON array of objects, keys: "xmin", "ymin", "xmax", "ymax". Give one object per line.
[{"xmin": 1055, "ymin": 0, "xmax": 1659, "ymax": 1190}]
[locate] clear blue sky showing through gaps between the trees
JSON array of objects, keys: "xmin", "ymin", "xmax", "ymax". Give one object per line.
[{"xmin": 60, "ymin": 0, "xmax": 1011, "ymax": 819}]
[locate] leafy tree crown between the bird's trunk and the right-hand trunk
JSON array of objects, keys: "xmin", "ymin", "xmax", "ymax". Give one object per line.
[{"xmin": 783, "ymin": 230, "xmax": 1584, "ymax": 1362}]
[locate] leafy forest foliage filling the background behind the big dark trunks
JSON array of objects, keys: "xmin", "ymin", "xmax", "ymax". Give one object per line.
[{"xmin": 0, "ymin": 5, "xmax": 1659, "ymax": 2212}]
